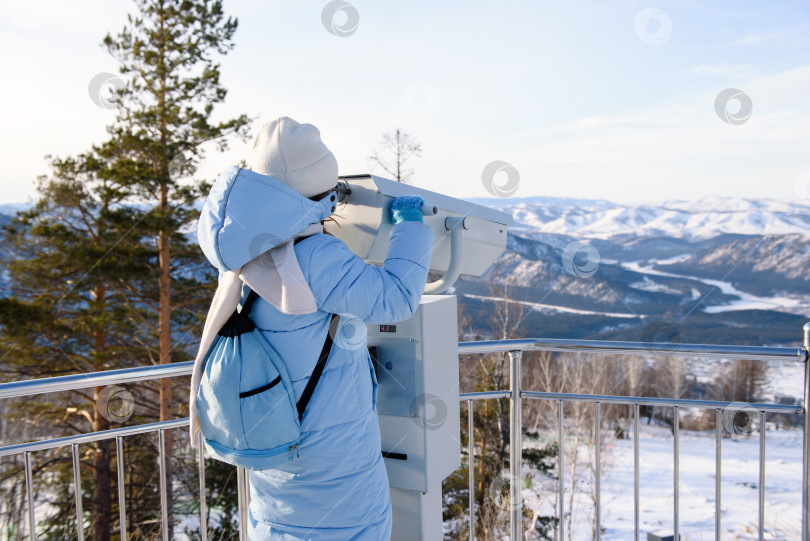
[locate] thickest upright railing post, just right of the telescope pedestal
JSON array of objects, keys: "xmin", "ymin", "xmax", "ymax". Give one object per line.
[{"xmin": 509, "ymin": 351, "xmax": 523, "ymax": 541}]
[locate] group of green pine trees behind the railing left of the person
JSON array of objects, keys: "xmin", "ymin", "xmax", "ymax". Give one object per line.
[{"xmin": 0, "ymin": 0, "xmax": 249, "ymax": 541}]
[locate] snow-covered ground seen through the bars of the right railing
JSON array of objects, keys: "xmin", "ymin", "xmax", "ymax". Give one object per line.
[{"xmin": 523, "ymin": 422, "xmax": 802, "ymax": 541}]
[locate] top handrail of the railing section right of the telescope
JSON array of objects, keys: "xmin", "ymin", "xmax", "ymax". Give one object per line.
[{"xmin": 458, "ymin": 338, "xmax": 807, "ymax": 362}]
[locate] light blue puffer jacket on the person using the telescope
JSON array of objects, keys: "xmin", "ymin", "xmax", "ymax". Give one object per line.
[{"xmin": 199, "ymin": 170, "xmax": 433, "ymax": 541}]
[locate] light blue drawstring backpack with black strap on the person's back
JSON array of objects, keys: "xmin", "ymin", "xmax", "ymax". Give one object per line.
[{"xmin": 196, "ymin": 291, "xmax": 339, "ymax": 470}]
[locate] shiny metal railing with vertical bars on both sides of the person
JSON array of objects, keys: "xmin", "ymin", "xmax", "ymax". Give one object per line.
[{"xmin": 0, "ymin": 323, "xmax": 810, "ymax": 541}]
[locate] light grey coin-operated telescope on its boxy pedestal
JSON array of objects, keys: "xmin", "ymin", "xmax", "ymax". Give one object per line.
[{"xmin": 326, "ymin": 175, "xmax": 512, "ymax": 541}]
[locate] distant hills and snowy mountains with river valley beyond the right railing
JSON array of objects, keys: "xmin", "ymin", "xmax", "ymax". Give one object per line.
[{"xmin": 0, "ymin": 197, "xmax": 810, "ymax": 345}]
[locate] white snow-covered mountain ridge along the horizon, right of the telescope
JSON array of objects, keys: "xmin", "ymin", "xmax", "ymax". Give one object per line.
[{"xmin": 474, "ymin": 197, "xmax": 810, "ymax": 239}]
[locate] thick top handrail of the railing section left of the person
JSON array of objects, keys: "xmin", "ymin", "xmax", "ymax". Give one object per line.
[{"xmin": 0, "ymin": 361, "xmax": 194, "ymax": 399}]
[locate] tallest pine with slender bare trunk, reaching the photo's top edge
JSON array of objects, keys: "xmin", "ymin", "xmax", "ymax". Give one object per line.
[{"xmin": 98, "ymin": 0, "xmax": 248, "ymax": 532}]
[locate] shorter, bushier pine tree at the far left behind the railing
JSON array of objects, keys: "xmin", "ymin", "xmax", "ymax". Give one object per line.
[{"xmin": 0, "ymin": 158, "xmax": 154, "ymax": 541}]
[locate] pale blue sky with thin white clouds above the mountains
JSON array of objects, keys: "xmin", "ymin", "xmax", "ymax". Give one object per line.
[{"xmin": 0, "ymin": 0, "xmax": 810, "ymax": 203}]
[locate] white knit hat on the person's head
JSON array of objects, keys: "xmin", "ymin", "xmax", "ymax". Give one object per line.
[{"xmin": 250, "ymin": 116, "xmax": 338, "ymax": 197}]
